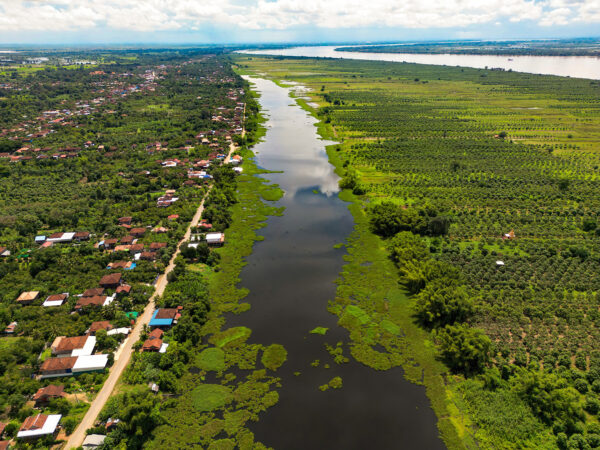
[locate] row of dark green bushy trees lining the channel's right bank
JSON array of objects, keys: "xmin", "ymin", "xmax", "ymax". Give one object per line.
[{"xmin": 369, "ymin": 208, "xmax": 492, "ymax": 375}]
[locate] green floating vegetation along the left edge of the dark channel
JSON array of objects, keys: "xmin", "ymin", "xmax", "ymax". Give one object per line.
[{"xmin": 146, "ymin": 86, "xmax": 287, "ymax": 450}]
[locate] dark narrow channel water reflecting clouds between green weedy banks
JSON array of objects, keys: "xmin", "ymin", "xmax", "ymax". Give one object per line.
[{"xmin": 227, "ymin": 75, "xmax": 444, "ymax": 449}]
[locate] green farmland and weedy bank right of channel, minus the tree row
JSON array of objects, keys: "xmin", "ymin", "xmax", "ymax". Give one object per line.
[{"xmin": 234, "ymin": 55, "xmax": 600, "ymax": 448}]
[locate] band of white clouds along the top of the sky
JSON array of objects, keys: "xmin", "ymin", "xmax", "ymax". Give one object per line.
[{"xmin": 0, "ymin": 0, "xmax": 600, "ymax": 32}]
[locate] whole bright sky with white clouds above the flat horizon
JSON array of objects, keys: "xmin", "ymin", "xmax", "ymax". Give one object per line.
[{"xmin": 0, "ymin": 0, "xmax": 600, "ymax": 45}]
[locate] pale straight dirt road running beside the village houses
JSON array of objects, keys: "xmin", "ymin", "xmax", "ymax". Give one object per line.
[{"xmin": 64, "ymin": 143, "xmax": 236, "ymax": 449}]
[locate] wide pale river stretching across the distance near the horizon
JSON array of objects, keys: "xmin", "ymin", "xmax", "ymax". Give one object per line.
[{"xmin": 241, "ymin": 45, "xmax": 600, "ymax": 80}]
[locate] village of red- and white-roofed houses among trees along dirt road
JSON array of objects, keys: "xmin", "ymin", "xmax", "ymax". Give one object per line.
[{"xmin": 0, "ymin": 51, "xmax": 245, "ymax": 449}]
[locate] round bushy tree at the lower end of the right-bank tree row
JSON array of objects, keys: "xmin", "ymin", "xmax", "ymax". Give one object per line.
[{"xmin": 436, "ymin": 325, "xmax": 492, "ymax": 375}]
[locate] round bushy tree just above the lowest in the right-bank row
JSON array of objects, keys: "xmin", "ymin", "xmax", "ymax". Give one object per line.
[{"xmin": 415, "ymin": 280, "xmax": 473, "ymax": 328}]
